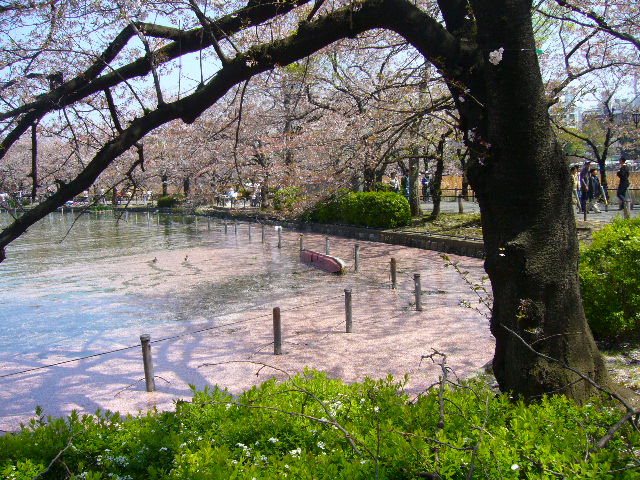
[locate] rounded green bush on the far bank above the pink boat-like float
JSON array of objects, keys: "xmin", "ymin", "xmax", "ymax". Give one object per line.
[{"xmin": 309, "ymin": 192, "xmax": 411, "ymax": 228}]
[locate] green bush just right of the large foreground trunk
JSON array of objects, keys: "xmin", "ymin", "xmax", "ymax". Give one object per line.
[{"xmin": 580, "ymin": 218, "xmax": 640, "ymax": 338}]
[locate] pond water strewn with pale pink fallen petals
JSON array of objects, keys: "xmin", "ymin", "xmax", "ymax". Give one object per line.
[{"xmin": 0, "ymin": 210, "xmax": 493, "ymax": 431}]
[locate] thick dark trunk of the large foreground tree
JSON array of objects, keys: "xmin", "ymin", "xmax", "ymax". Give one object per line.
[{"xmin": 469, "ymin": 0, "xmax": 613, "ymax": 400}]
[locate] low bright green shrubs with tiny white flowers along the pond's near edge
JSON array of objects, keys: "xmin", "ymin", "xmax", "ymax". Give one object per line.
[{"xmin": 0, "ymin": 371, "xmax": 640, "ymax": 480}]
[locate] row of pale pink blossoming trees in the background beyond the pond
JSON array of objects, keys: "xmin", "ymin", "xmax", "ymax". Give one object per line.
[{"xmin": 0, "ymin": 5, "xmax": 640, "ymax": 211}]
